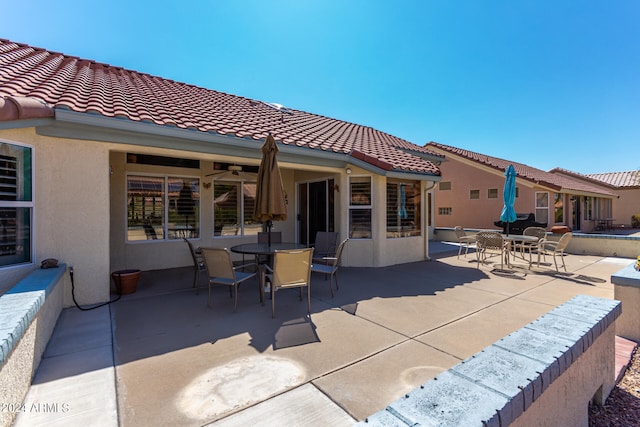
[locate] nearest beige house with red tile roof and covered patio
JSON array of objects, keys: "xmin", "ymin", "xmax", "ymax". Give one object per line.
[{"xmin": 0, "ymin": 39, "xmax": 442, "ymax": 304}]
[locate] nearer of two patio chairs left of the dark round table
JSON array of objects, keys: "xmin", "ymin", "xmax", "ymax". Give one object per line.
[{"xmin": 200, "ymin": 248, "xmax": 262, "ymax": 311}]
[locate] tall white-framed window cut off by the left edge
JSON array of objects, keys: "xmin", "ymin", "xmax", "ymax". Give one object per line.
[{"xmin": 0, "ymin": 142, "xmax": 34, "ymax": 267}]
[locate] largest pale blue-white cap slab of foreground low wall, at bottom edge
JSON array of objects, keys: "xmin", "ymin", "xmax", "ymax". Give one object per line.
[{"xmin": 387, "ymin": 371, "xmax": 508, "ymax": 426}]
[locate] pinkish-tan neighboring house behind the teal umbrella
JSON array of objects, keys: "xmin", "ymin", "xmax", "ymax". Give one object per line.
[{"xmin": 425, "ymin": 142, "xmax": 617, "ymax": 231}]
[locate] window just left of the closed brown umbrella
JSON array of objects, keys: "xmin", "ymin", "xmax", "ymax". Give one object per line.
[{"xmin": 213, "ymin": 181, "xmax": 262, "ymax": 236}]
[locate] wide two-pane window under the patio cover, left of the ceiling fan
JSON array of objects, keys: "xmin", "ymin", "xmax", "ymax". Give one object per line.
[{"xmin": 127, "ymin": 176, "xmax": 200, "ymax": 241}]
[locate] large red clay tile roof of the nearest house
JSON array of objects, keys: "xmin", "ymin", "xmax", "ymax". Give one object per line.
[{"xmin": 0, "ymin": 39, "xmax": 440, "ymax": 176}]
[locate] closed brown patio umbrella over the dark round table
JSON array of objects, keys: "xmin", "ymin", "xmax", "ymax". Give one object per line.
[{"xmin": 253, "ymin": 134, "xmax": 287, "ymax": 246}]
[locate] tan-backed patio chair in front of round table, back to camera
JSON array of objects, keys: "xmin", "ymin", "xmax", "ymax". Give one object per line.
[{"xmin": 260, "ymin": 248, "xmax": 313, "ymax": 317}]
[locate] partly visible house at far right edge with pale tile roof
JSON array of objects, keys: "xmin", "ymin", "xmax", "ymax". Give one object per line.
[{"xmin": 550, "ymin": 168, "xmax": 640, "ymax": 231}]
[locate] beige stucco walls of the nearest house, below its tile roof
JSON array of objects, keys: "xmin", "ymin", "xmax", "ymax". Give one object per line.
[{"xmin": 0, "ymin": 127, "xmax": 433, "ymax": 306}]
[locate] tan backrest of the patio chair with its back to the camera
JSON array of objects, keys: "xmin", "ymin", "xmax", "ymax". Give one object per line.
[{"xmin": 273, "ymin": 248, "xmax": 313, "ymax": 288}]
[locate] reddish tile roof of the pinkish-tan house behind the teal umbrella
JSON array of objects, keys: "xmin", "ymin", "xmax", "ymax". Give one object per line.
[{"xmin": 425, "ymin": 142, "xmax": 616, "ymax": 197}]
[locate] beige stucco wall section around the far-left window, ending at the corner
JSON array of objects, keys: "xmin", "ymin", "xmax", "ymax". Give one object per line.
[{"xmin": 0, "ymin": 129, "xmax": 110, "ymax": 307}]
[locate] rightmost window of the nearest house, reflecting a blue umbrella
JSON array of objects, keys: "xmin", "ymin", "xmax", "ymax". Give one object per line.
[{"xmin": 387, "ymin": 179, "xmax": 420, "ymax": 237}]
